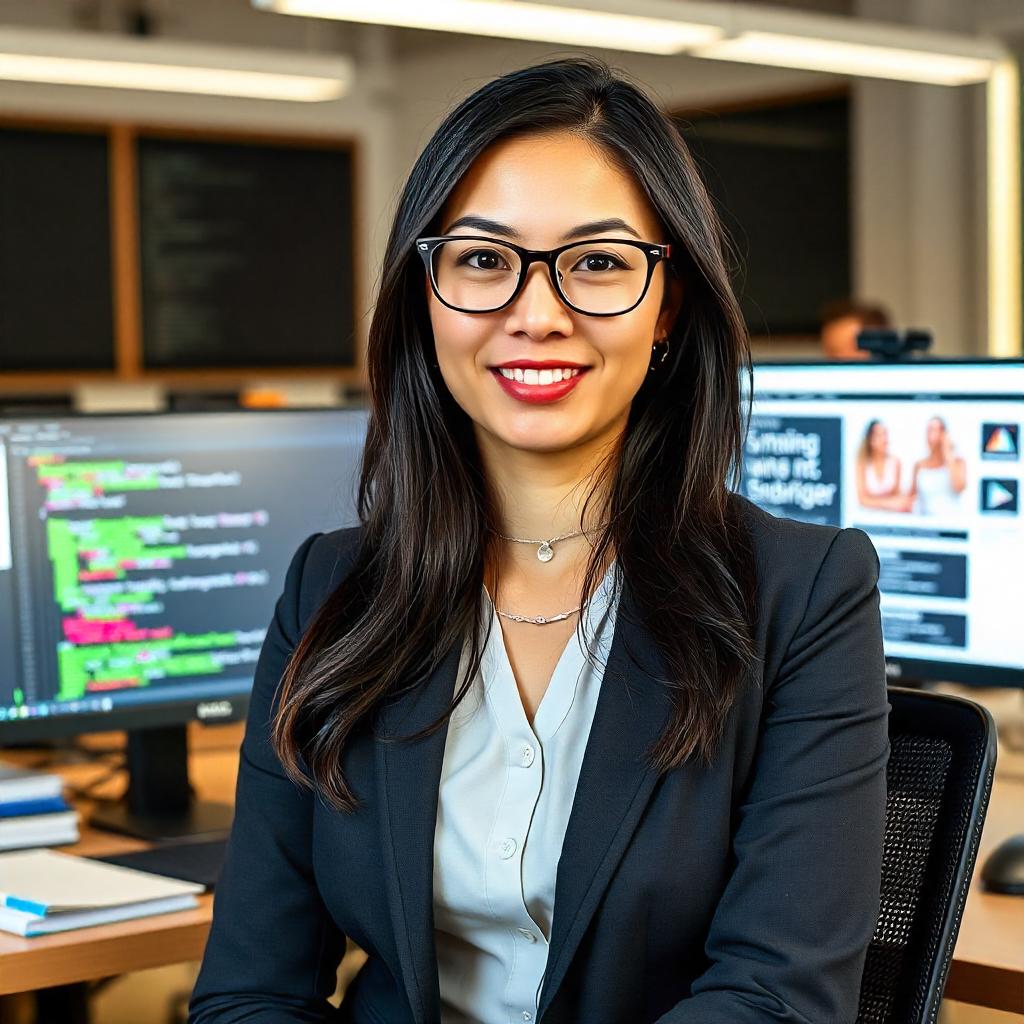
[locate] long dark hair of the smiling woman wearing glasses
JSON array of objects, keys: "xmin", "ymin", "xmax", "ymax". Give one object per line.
[{"xmin": 272, "ymin": 57, "xmax": 756, "ymax": 810}]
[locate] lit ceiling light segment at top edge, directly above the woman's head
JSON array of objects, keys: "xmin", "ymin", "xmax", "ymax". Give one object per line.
[{"xmin": 253, "ymin": 0, "xmax": 722, "ymax": 54}]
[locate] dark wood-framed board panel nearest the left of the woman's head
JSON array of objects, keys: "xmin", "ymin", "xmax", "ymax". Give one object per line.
[{"xmin": 138, "ymin": 133, "xmax": 355, "ymax": 370}]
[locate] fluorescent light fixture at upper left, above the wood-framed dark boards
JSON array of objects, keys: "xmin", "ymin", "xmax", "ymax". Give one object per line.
[{"xmin": 0, "ymin": 29, "xmax": 351, "ymax": 102}]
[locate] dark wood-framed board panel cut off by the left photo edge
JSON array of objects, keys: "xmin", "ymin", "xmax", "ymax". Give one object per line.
[{"xmin": 0, "ymin": 128, "xmax": 114, "ymax": 372}]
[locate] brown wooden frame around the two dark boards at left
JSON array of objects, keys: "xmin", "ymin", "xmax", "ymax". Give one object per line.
[{"xmin": 0, "ymin": 115, "xmax": 366, "ymax": 394}]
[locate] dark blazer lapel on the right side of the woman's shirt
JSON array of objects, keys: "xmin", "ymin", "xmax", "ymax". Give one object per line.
[{"xmin": 538, "ymin": 585, "xmax": 671, "ymax": 1020}]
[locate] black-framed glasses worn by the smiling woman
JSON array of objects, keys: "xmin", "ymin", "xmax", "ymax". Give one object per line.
[{"xmin": 416, "ymin": 234, "xmax": 672, "ymax": 316}]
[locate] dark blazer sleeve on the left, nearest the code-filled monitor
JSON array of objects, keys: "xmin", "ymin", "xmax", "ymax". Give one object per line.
[{"xmin": 188, "ymin": 534, "xmax": 344, "ymax": 1024}]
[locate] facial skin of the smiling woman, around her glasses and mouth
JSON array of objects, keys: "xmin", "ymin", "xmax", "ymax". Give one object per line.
[{"xmin": 424, "ymin": 133, "xmax": 681, "ymax": 453}]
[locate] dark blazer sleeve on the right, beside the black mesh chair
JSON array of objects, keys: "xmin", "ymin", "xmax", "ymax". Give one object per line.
[{"xmin": 657, "ymin": 528, "xmax": 890, "ymax": 1024}]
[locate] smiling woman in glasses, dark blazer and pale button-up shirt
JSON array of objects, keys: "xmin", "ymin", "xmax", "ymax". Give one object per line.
[{"xmin": 190, "ymin": 58, "xmax": 889, "ymax": 1024}]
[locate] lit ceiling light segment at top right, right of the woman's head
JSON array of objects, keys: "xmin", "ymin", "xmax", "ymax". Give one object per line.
[{"xmin": 692, "ymin": 32, "xmax": 995, "ymax": 85}]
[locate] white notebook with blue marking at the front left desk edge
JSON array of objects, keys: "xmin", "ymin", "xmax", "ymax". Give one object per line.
[{"xmin": 0, "ymin": 850, "xmax": 203, "ymax": 935}]
